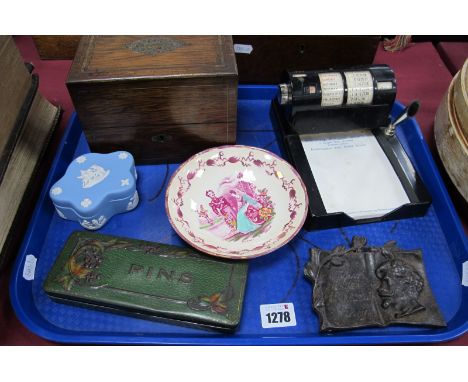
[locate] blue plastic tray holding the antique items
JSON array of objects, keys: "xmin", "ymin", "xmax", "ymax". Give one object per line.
[{"xmin": 10, "ymin": 86, "xmax": 468, "ymax": 345}]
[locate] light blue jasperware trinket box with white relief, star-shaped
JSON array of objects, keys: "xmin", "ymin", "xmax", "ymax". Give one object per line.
[{"xmin": 49, "ymin": 151, "xmax": 139, "ymax": 230}]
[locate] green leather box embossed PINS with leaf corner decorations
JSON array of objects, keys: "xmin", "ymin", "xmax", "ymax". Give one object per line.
[{"xmin": 44, "ymin": 232, "xmax": 247, "ymax": 331}]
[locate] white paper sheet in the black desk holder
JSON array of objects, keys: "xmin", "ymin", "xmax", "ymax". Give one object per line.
[{"xmin": 301, "ymin": 130, "xmax": 409, "ymax": 219}]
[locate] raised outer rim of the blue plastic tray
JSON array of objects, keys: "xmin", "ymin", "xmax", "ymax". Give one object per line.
[{"xmin": 9, "ymin": 85, "xmax": 468, "ymax": 346}]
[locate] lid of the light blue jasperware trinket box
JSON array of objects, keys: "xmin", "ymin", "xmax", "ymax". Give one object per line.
[{"xmin": 49, "ymin": 151, "xmax": 137, "ymax": 217}]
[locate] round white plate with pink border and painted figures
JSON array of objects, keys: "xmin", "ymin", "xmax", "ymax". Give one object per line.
[{"xmin": 166, "ymin": 146, "xmax": 308, "ymax": 259}]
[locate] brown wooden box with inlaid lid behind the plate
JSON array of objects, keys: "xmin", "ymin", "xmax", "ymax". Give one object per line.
[{"xmin": 67, "ymin": 36, "xmax": 237, "ymax": 163}]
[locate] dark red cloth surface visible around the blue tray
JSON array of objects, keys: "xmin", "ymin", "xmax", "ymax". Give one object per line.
[{"xmin": 0, "ymin": 36, "xmax": 468, "ymax": 345}]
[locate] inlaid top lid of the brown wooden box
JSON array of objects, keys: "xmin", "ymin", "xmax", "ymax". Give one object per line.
[{"xmin": 67, "ymin": 36, "xmax": 237, "ymax": 84}]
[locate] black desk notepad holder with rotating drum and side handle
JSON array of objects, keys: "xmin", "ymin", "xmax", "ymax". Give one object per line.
[{"xmin": 272, "ymin": 65, "xmax": 431, "ymax": 229}]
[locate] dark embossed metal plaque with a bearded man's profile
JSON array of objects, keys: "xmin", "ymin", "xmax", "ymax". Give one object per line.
[{"xmin": 304, "ymin": 236, "xmax": 446, "ymax": 331}]
